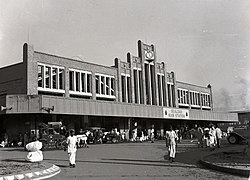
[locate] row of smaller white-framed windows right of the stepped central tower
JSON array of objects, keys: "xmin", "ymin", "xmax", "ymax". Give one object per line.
[{"xmin": 177, "ymin": 89, "xmax": 210, "ymax": 107}]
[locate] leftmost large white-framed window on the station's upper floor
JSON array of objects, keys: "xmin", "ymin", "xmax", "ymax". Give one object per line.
[{"xmin": 37, "ymin": 63, "xmax": 65, "ymax": 93}]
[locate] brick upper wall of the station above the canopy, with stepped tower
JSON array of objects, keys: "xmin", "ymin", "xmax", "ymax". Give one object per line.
[{"xmin": 0, "ymin": 41, "xmax": 213, "ymax": 110}]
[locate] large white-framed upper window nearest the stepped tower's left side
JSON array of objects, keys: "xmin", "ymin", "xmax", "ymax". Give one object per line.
[{"xmin": 95, "ymin": 73, "xmax": 115, "ymax": 99}]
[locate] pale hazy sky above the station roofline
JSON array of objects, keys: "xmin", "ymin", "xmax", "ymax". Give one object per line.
[{"xmin": 0, "ymin": 0, "xmax": 250, "ymax": 111}]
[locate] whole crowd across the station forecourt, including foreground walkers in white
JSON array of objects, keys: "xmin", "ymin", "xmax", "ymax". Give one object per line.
[{"xmin": 1, "ymin": 124, "xmax": 223, "ymax": 167}]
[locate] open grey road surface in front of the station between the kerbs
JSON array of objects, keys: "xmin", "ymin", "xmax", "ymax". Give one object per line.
[{"xmin": 44, "ymin": 140, "xmax": 247, "ymax": 180}]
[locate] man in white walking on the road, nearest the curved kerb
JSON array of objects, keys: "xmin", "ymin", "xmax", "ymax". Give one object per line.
[{"xmin": 67, "ymin": 130, "xmax": 77, "ymax": 168}]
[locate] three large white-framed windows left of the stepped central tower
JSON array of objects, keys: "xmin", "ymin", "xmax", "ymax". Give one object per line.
[{"xmin": 38, "ymin": 64, "xmax": 115, "ymax": 99}]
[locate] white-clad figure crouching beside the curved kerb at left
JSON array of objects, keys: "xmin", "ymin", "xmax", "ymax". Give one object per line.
[{"xmin": 26, "ymin": 137, "xmax": 43, "ymax": 162}]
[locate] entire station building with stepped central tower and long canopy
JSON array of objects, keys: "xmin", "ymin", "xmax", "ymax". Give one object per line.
[{"xmin": 0, "ymin": 41, "xmax": 238, "ymax": 141}]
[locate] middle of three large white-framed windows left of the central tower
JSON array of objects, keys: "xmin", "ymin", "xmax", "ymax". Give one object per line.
[{"xmin": 69, "ymin": 69, "xmax": 92, "ymax": 96}]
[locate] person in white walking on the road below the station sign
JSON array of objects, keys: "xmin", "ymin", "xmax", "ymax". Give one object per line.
[{"xmin": 167, "ymin": 126, "xmax": 178, "ymax": 162}]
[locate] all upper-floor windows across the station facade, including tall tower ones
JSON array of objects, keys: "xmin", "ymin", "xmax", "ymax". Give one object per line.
[{"xmin": 38, "ymin": 64, "xmax": 210, "ymax": 107}]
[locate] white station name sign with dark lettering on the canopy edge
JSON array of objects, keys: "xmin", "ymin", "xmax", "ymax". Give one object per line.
[{"xmin": 163, "ymin": 108, "xmax": 189, "ymax": 119}]
